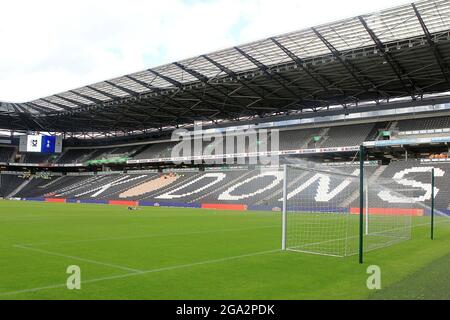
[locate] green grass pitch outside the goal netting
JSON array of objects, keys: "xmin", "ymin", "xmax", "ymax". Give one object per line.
[{"xmin": 0, "ymin": 201, "xmax": 450, "ymax": 299}]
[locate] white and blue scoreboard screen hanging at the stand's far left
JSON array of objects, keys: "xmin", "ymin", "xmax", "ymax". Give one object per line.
[{"xmin": 19, "ymin": 134, "xmax": 62, "ymax": 153}]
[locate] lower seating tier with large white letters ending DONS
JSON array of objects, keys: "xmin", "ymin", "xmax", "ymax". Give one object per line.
[{"xmin": 6, "ymin": 160, "xmax": 450, "ymax": 210}]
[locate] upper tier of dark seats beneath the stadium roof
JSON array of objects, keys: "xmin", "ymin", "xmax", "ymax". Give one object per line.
[{"xmin": 0, "ymin": 117, "xmax": 450, "ymax": 164}]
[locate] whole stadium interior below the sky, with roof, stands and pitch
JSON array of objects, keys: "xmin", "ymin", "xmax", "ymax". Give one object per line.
[{"xmin": 0, "ymin": 0, "xmax": 450, "ymax": 299}]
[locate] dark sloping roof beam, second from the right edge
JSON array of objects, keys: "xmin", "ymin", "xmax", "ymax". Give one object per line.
[{"xmin": 358, "ymin": 16, "xmax": 422, "ymax": 99}]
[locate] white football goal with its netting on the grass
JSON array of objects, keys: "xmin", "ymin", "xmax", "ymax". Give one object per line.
[{"xmin": 282, "ymin": 163, "xmax": 418, "ymax": 257}]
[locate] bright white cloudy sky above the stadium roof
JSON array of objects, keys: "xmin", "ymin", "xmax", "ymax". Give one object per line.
[{"xmin": 0, "ymin": 0, "xmax": 411, "ymax": 102}]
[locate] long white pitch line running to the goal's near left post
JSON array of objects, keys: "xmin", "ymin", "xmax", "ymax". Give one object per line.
[{"xmin": 0, "ymin": 249, "xmax": 281, "ymax": 296}]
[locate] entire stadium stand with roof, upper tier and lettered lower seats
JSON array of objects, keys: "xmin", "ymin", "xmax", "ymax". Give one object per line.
[{"xmin": 0, "ymin": 0, "xmax": 450, "ymax": 220}]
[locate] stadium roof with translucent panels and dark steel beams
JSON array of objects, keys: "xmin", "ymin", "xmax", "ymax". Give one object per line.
[{"xmin": 0, "ymin": 0, "xmax": 450, "ymax": 135}]
